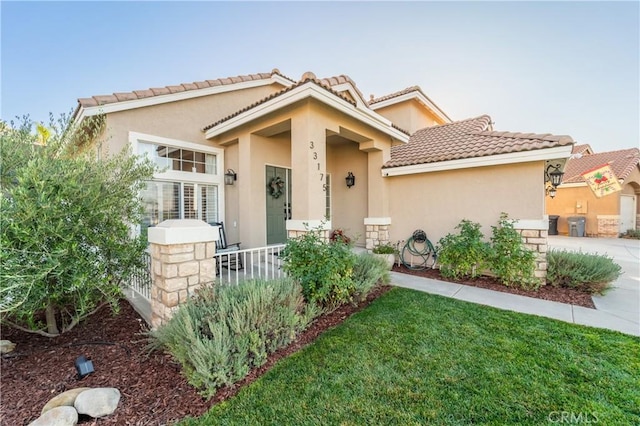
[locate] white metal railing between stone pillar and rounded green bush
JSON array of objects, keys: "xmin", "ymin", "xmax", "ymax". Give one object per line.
[{"xmin": 213, "ymin": 244, "xmax": 285, "ymax": 284}]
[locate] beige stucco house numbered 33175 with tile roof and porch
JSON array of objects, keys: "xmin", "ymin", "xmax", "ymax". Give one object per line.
[{"xmin": 75, "ymin": 69, "xmax": 573, "ymax": 278}]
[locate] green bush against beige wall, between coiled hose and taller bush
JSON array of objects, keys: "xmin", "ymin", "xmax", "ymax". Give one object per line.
[{"xmin": 437, "ymin": 219, "xmax": 490, "ymax": 279}]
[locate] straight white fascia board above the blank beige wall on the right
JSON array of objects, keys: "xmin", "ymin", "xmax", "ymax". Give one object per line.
[{"xmin": 382, "ymin": 144, "xmax": 573, "ymax": 176}]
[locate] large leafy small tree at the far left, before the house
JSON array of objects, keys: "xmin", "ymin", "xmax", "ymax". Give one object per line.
[{"xmin": 0, "ymin": 116, "xmax": 154, "ymax": 337}]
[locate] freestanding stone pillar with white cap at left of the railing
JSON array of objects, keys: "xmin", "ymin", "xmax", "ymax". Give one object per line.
[{"xmin": 149, "ymin": 219, "xmax": 218, "ymax": 329}]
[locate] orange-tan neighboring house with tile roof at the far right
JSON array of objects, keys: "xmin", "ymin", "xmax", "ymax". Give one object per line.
[{"xmin": 547, "ymin": 145, "xmax": 640, "ymax": 237}]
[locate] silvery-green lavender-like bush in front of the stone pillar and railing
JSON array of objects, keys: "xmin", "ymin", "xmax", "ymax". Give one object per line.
[{"xmin": 150, "ymin": 279, "xmax": 318, "ymax": 397}]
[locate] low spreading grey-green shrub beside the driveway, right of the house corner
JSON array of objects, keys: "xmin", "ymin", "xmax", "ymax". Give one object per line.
[{"xmin": 547, "ymin": 250, "xmax": 622, "ymax": 294}]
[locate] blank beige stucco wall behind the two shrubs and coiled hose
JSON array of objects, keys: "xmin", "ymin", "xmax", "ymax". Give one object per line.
[{"xmin": 386, "ymin": 161, "xmax": 544, "ymax": 244}]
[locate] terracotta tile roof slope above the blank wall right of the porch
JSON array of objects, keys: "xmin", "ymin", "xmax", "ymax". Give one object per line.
[{"xmin": 383, "ymin": 115, "xmax": 573, "ymax": 168}]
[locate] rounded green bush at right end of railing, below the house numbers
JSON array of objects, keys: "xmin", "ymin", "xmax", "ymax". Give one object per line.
[{"xmin": 281, "ymin": 228, "xmax": 356, "ymax": 309}]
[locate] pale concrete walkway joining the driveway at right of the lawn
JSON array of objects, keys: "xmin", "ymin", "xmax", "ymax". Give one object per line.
[{"xmin": 391, "ymin": 236, "xmax": 640, "ymax": 336}]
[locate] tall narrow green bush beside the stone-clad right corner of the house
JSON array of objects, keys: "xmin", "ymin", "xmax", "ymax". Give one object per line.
[{"xmin": 489, "ymin": 213, "xmax": 541, "ymax": 289}]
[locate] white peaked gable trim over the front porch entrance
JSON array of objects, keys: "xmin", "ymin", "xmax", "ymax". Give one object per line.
[{"xmin": 205, "ymin": 81, "xmax": 409, "ymax": 142}]
